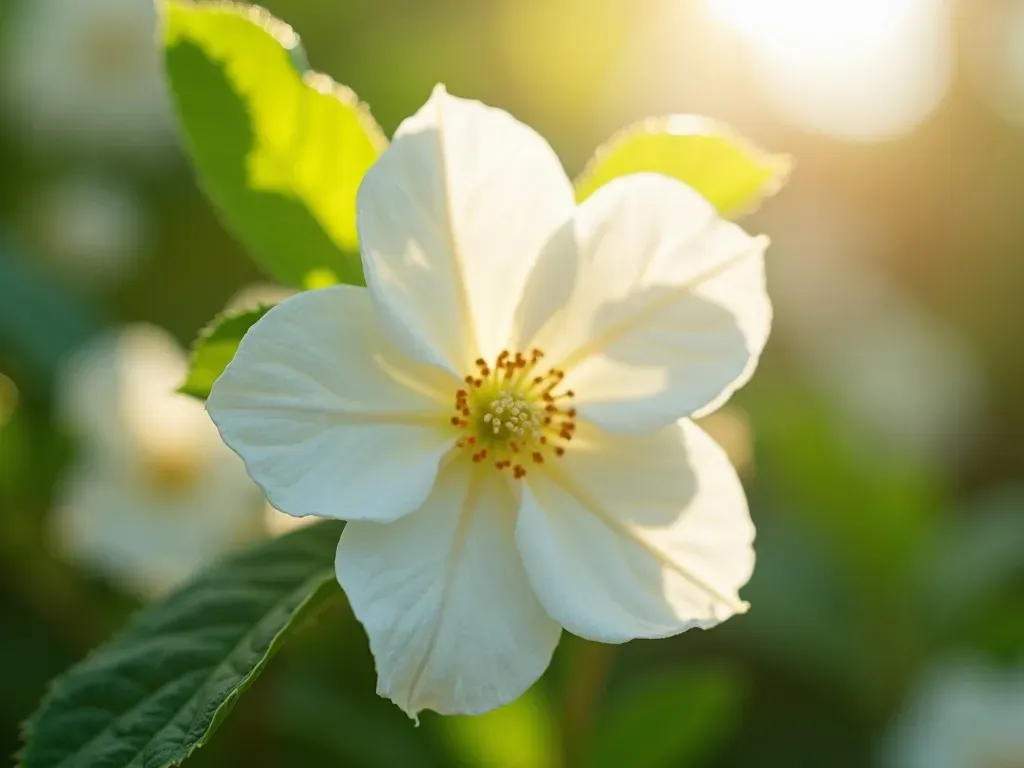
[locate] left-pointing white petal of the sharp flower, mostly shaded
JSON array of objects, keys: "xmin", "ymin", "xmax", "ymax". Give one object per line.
[{"xmin": 207, "ymin": 286, "xmax": 458, "ymax": 520}]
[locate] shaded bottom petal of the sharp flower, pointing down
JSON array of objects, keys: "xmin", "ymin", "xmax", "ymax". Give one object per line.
[{"xmin": 336, "ymin": 459, "xmax": 561, "ymax": 717}]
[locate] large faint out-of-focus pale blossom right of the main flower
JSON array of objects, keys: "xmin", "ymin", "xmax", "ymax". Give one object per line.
[{"xmin": 771, "ymin": 196, "xmax": 986, "ymax": 462}]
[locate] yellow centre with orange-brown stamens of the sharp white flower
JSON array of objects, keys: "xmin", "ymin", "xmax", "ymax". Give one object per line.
[{"xmin": 452, "ymin": 349, "xmax": 575, "ymax": 479}]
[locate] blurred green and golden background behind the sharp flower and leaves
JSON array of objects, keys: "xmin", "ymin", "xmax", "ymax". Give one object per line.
[{"xmin": 0, "ymin": 0, "xmax": 1024, "ymax": 768}]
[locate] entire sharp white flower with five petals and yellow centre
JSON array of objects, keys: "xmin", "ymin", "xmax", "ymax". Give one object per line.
[{"xmin": 208, "ymin": 87, "xmax": 771, "ymax": 714}]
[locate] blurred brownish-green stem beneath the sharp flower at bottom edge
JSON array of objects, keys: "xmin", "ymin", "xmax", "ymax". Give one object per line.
[{"xmin": 562, "ymin": 637, "xmax": 615, "ymax": 768}]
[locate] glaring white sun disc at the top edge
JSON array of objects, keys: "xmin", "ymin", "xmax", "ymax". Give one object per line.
[{"xmin": 707, "ymin": 0, "xmax": 952, "ymax": 140}]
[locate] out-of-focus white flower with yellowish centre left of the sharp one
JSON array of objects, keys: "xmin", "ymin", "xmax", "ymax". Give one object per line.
[{"xmin": 56, "ymin": 326, "xmax": 263, "ymax": 596}]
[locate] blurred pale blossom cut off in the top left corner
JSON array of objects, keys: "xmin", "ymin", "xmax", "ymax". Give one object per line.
[{"xmin": 0, "ymin": 0, "xmax": 176, "ymax": 158}]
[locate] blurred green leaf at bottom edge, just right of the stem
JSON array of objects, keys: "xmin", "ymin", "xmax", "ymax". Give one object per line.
[{"xmin": 584, "ymin": 668, "xmax": 744, "ymax": 768}]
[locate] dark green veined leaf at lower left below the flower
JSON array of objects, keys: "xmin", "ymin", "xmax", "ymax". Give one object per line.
[{"xmin": 22, "ymin": 522, "xmax": 342, "ymax": 768}]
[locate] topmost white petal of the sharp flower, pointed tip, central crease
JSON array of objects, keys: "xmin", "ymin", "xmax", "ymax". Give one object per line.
[{"xmin": 357, "ymin": 86, "xmax": 574, "ymax": 375}]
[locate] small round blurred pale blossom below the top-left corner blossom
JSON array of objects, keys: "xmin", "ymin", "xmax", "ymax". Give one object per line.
[{"xmin": 29, "ymin": 174, "xmax": 147, "ymax": 288}]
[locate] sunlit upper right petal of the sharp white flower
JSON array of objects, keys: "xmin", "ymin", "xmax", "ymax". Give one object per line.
[{"xmin": 519, "ymin": 174, "xmax": 771, "ymax": 432}]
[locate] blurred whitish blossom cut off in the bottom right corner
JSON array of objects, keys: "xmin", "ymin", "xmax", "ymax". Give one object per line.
[{"xmin": 883, "ymin": 660, "xmax": 1024, "ymax": 768}]
